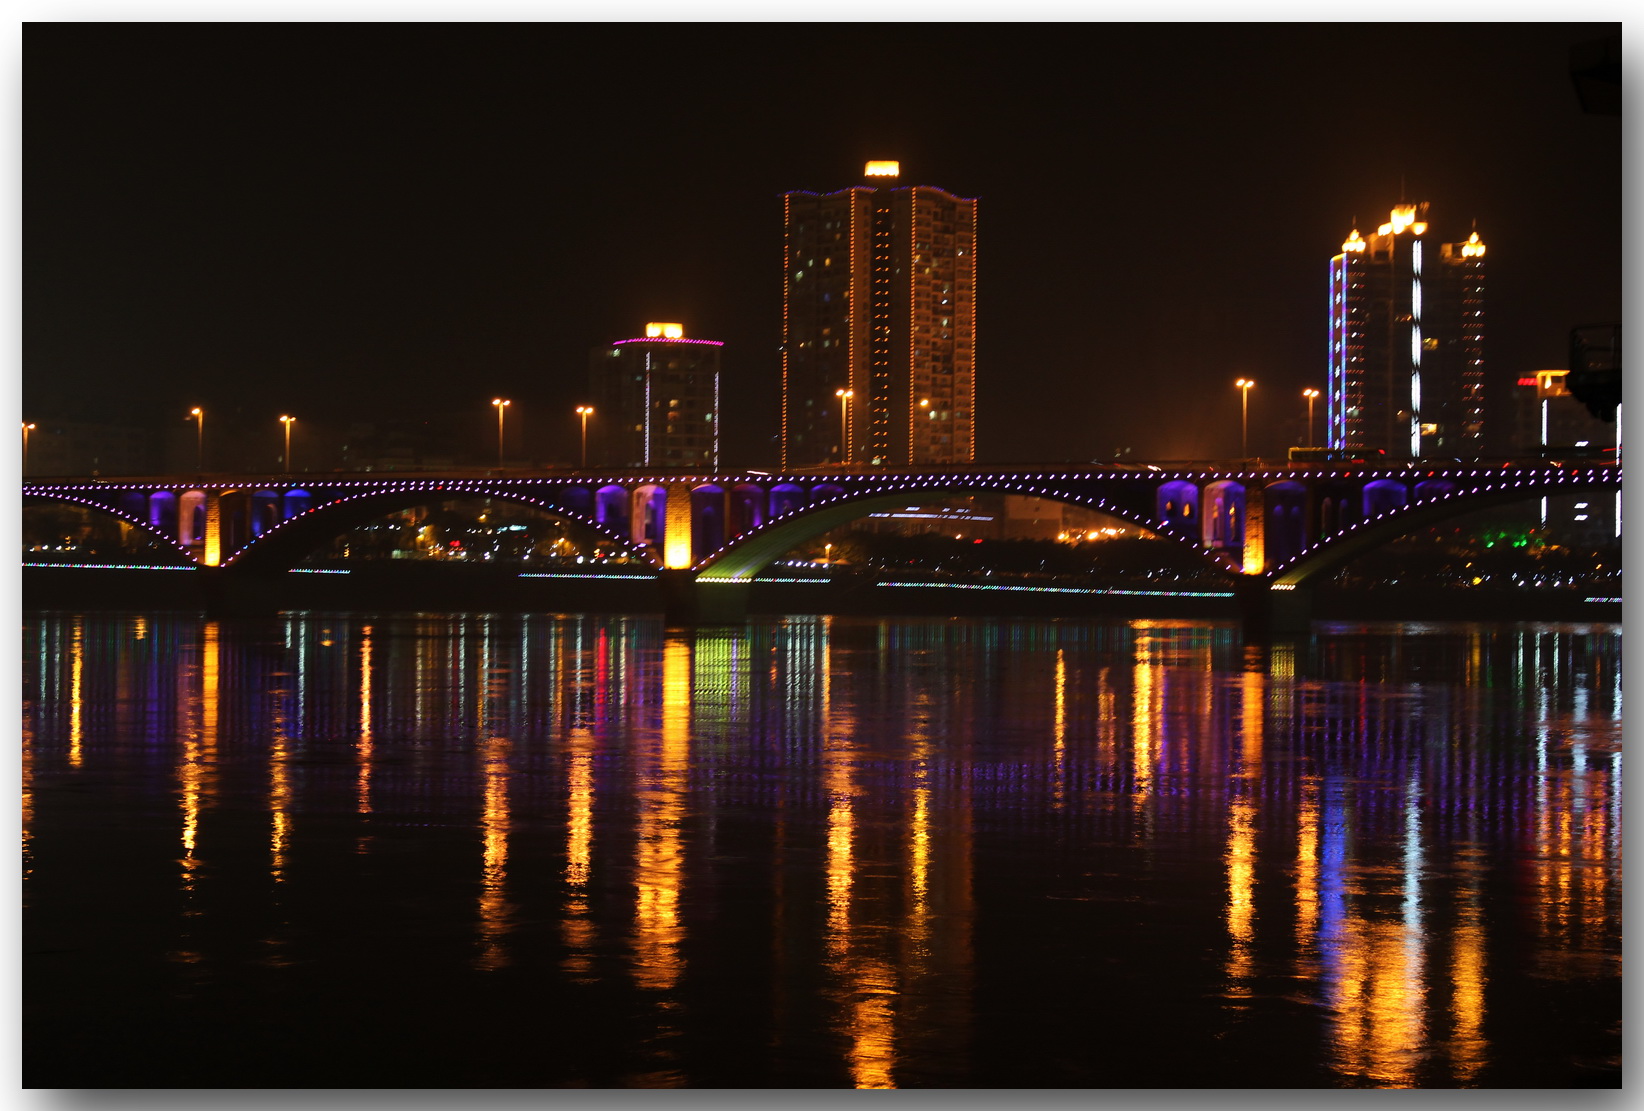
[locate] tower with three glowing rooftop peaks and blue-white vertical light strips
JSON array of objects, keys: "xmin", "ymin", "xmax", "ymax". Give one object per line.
[{"xmin": 1327, "ymin": 204, "xmax": 1485, "ymax": 459}]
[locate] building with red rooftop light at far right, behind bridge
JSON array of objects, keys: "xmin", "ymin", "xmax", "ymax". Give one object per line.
[{"xmin": 1512, "ymin": 370, "xmax": 1621, "ymax": 541}]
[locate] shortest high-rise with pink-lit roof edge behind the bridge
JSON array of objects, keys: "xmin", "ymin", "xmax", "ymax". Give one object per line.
[{"xmin": 584, "ymin": 324, "xmax": 723, "ymax": 470}]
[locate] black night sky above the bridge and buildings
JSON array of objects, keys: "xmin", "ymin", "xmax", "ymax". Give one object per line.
[{"xmin": 23, "ymin": 23, "xmax": 1623, "ymax": 467}]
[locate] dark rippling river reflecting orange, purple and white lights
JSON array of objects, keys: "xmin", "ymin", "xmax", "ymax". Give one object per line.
[{"xmin": 23, "ymin": 613, "xmax": 1621, "ymax": 1088}]
